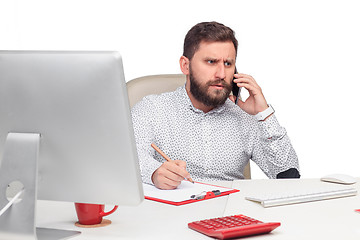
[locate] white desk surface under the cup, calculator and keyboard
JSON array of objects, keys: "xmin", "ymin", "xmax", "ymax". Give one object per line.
[{"xmin": 37, "ymin": 179, "xmax": 360, "ymax": 240}]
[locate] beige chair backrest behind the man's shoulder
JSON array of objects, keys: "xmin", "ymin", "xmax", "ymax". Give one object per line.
[{"xmin": 126, "ymin": 74, "xmax": 251, "ymax": 179}]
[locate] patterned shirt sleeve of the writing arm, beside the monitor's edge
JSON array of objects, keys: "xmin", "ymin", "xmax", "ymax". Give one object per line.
[{"xmin": 131, "ymin": 98, "xmax": 162, "ymax": 184}]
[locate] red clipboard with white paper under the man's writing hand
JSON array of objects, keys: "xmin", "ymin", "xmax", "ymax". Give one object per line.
[{"xmin": 143, "ymin": 181, "xmax": 240, "ymax": 206}]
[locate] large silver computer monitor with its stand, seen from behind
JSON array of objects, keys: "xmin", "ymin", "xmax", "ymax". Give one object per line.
[{"xmin": 0, "ymin": 51, "xmax": 144, "ymax": 239}]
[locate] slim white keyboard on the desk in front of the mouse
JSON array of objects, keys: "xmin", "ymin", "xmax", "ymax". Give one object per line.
[{"xmin": 245, "ymin": 188, "xmax": 357, "ymax": 207}]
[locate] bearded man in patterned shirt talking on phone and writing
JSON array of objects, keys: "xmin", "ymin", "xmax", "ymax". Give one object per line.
[{"xmin": 132, "ymin": 22, "xmax": 300, "ymax": 189}]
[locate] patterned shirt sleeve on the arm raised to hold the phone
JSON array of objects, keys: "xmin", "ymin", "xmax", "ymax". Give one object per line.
[{"xmin": 252, "ymin": 114, "xmax": 300, "ymax": 178}]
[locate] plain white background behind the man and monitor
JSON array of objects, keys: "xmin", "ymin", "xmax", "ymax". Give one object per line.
[{"xmin": 0, "ymin": 0, "xmax": 360, "ymax": 178}]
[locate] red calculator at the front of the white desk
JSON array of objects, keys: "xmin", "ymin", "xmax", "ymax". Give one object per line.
[{"xmin": 188, "ymin": 214, "xmax": 280, "ymax": 239}]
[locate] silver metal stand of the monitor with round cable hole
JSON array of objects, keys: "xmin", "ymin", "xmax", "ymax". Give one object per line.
[{"xmin": 0, "ymin": 133, "xmax": 80, "ymax": 240}]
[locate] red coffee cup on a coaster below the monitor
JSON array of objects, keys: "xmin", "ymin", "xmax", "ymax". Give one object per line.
[{"xmin": 75, "ymin": 203, "xmax": 118, "ymax": 225}]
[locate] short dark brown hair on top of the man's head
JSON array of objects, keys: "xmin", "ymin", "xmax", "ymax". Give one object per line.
[{"xmin": 183, "ymin": 22, "xmax": 238, "ymax": 60}]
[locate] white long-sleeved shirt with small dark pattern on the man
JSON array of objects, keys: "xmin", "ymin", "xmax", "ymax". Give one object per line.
[{"xmin": 132, "ymin": 86, "xmax": 299, "ymax": 183}]
